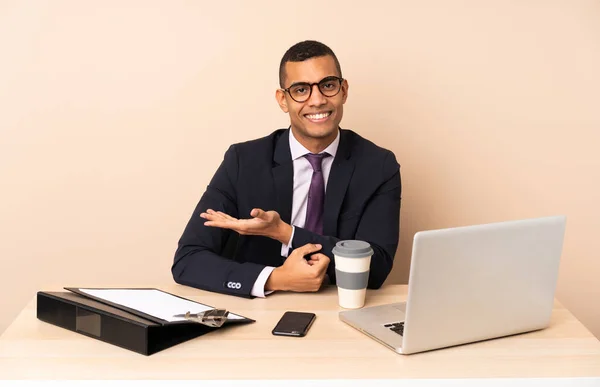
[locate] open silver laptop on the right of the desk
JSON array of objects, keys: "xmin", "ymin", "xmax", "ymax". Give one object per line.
[{"xmin": 339, "ymin": 216, "xmax": 566, "ymax": 354}]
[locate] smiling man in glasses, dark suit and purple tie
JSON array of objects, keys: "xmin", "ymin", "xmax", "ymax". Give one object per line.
[{"xmin": 171, "ymin": 41, "xmax": 401, "ymax": 297}]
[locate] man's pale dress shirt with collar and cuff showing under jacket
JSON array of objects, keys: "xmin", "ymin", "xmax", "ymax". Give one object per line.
[{"xmin": 250, "ymin": 129, "xmax": 340, "ymax": 297}]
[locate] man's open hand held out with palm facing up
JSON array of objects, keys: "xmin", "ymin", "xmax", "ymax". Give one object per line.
[{"xmin": 200, "ymin": 208, "xmax": 292, "ymax": 244}]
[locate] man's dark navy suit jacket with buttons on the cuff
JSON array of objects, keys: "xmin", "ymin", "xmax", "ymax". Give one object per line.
[{"xmin": 171, "ymin": 129, "xmax": 401, "ymax": 297}]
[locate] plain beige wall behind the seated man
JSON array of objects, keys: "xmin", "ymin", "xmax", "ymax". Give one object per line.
[{"xmin": 0, "ymin": 0, "xmax": 600, "ymax": 336}]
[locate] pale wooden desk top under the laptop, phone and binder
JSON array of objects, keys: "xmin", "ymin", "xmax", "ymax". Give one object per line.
[{"xmin": 0, "ymin": 284, "xmax": 600, "ymax": 380}]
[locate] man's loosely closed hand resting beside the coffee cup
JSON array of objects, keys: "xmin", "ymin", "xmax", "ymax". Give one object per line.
[{"xmin": 265, "ymin": 243, "xmax": 330, "ymax": 292}]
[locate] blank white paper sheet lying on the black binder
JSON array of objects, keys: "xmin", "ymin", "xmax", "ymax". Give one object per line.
[{"xmin": 79, "ymin": 288, "xmax": 244, "ymax": 322}]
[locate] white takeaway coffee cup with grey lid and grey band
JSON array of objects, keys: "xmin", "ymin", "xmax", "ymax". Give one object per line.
[{"xmin": 333, "ymin": 240, "xmax": 373, "ymax": 309}]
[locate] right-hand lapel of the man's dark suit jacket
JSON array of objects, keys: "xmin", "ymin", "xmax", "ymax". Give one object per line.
[{"xmin": 323, "ymin": 129, "xmax": 354, "ymax": 236}]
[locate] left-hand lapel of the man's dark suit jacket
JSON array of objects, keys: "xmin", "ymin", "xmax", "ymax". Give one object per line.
[{"xmin": 272, "ymin": 129, "xmax": 294, "ymax": 224}]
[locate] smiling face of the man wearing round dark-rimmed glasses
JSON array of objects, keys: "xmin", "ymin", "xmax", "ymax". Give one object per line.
[{"xmin": 276, "ymin": 55, "xmax": 348, "ymax": 141}]
